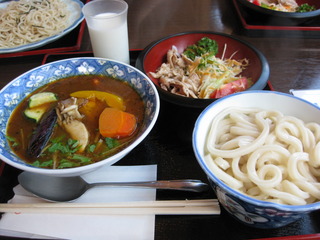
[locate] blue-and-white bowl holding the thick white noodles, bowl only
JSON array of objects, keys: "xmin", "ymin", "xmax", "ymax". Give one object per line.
[{"xmin": 192, "ymin": 90, "xmax": 320, "ymax": 229}]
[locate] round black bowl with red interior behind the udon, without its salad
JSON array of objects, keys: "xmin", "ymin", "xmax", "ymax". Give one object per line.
[{"xmin": 136, "ymin": 31, "xmax": 270, "ymax": 108}]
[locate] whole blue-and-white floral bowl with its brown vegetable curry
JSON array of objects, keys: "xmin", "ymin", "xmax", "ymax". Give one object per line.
[{"xmin": 0, "ymin": 57, "xmax": 160, "ymax": 176}]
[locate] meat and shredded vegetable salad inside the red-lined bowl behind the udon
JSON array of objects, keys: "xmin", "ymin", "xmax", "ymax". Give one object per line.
[{"xmin": 150, "ymin": 37, "xmax": 252, "ymax": 99}]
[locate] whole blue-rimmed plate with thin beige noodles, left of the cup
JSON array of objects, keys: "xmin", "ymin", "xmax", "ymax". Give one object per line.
[{"xmin": 0, "ymin": 0, "xmax": 84, "ymax": 54}]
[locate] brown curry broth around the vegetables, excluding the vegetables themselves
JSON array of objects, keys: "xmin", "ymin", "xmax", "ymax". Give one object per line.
[{"xmin": 7, "ymin": 75, "xmax": 144, "ymax": 169}]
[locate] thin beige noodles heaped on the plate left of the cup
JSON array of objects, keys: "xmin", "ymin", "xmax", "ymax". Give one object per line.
[{"xmin": 0, "ymin": 0, "xmax": 70, "ymax": 48}]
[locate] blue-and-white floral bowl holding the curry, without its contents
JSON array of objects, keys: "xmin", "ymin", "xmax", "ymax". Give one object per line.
[{"xmin": 0, "ymin": 57, "xmax": 160, "ymax": 176}]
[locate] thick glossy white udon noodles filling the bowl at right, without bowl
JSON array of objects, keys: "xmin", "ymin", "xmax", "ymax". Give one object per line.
[{"xmin": 205, "ymin": 107, "xmax": 320, "ymax": 205}]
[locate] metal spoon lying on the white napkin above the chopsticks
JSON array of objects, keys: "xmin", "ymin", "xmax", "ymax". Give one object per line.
[{"xmin": 18, "ymin": 172, "xmax": 208, "ymax": 202}]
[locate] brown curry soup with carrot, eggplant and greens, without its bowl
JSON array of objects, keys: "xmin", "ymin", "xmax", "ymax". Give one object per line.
[{"xmin": 7, "ymin": 75, "xmax": 144, "ymax": 169}]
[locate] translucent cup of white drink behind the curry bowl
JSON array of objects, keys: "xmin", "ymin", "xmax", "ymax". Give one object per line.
[{"xmin": 82, "ymin": 0, "xmax": 130, "ymax": 64}]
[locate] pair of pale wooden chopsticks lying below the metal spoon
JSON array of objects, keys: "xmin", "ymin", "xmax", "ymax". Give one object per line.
[{"xmin": 0, "ymin": 199, "xmax": 220, "ymax": 215}]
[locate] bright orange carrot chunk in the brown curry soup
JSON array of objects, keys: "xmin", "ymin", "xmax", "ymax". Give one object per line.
[{"xmin": 99, "ymin": 108, "xmax": 137, "ymax": 138}]
